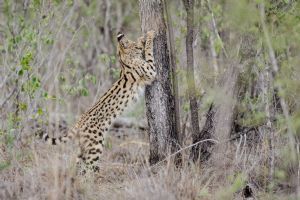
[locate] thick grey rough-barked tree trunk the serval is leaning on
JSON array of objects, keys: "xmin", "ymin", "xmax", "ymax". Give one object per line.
[{"xmin": 140, "ymin": 0, "xmax": 178, "ymax": 164}]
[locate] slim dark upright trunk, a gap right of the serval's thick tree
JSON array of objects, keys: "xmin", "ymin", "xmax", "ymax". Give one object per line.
[{"xmin": 183, "ymin": 0, "xmax": 200, "ymax": 158}]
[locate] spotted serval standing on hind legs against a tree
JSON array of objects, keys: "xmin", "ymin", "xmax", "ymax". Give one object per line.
[{"xmin": 42, "ymin": 31, "xmax": 156, "ymax": 168}]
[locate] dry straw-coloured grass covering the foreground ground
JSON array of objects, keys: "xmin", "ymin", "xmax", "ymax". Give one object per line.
[{"xmin": 0, "ymin": 124, "xmax": 295, "ymax": 200}]
